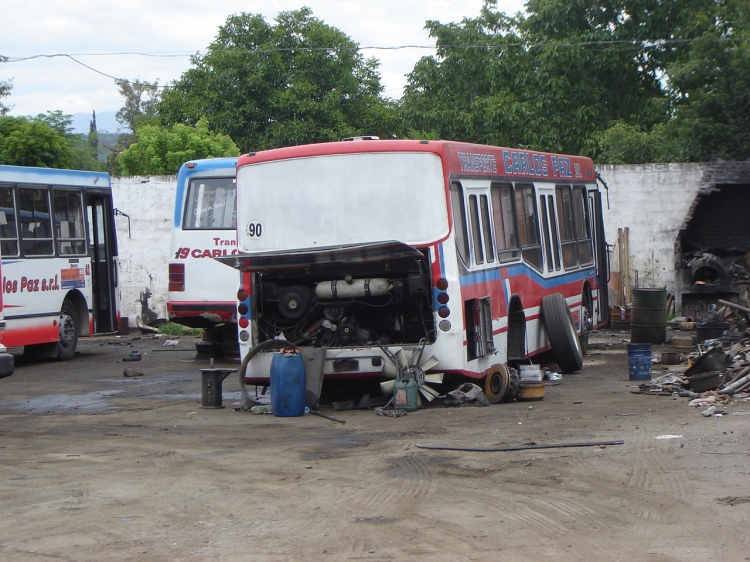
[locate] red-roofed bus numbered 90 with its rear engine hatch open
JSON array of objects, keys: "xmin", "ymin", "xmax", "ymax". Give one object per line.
[{"xmin": 221, "ymin": 138, "xmax": 608, "ymax": 402}]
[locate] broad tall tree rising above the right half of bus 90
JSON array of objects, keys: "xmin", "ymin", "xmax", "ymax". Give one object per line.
[{"xmin": 402, "ymin": 0, "xmax": 717, "ymax": 156}]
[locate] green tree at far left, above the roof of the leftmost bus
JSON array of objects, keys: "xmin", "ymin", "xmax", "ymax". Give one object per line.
[{"xmin": 0, "ymin": 116, "xmax": 75, "ymax": 168}]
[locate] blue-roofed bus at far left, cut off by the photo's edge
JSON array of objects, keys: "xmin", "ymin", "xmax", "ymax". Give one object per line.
[{"xmin": 0, "ymin": 166, "xmax": 120, "ymax": 359}]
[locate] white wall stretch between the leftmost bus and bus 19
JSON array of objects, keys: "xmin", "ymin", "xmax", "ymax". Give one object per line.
[{"xmin": 112, "ymin": 176, "xmax": 177, "ymax": 326}]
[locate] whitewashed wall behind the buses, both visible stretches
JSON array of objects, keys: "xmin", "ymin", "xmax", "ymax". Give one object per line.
[{"xmin": 112, "ymin": 164, "xmax": 707, "ymax": 325}]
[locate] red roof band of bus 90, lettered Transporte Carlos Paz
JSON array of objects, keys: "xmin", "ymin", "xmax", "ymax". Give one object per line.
[{"xmin": 237, "ymin": 140, "xmax": 596, "ymax": 181}]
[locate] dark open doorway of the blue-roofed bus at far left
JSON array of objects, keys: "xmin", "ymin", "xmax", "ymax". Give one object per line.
[{"xmin": 86, "ymin": 193, "xmax": 118, "ymax": 334}]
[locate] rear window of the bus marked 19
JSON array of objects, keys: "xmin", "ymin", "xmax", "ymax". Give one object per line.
[{"xmin": 183, "ymin": 178, "xmax": 237, "ymax": 226}]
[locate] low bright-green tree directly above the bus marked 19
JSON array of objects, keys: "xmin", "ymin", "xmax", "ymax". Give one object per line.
[{"xmin": 116, "ymin": 118, "xmax": 240, "ymax": 176}]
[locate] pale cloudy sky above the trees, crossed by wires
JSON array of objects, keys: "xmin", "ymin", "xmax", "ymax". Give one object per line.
[{"xmin": 0, "ymin": 0, "xmax": 524, "ymax": 126}]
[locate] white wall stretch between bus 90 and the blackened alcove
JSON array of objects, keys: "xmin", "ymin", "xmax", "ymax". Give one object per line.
[{"xmin": 597, "ymin": 164, "xmax": 708, "ymax": 304}]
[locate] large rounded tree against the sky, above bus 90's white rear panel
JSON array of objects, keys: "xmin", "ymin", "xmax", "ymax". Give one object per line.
[{"xmin": 158, "ymin": 8, "xmax": 399, "ymax": 151}]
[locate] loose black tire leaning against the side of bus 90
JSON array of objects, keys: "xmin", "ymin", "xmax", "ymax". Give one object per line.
[{"xmin": 542, "ymin": 293, "xmax": 583, "ymax": 373}]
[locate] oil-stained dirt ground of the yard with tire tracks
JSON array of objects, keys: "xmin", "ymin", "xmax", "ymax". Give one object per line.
[{"xmin": 0, "ymin": 331, "xmax": 750, "ymax": 562}]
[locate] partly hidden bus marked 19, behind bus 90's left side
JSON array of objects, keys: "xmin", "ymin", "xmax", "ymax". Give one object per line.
[{"xmin": 167, "ymin": 158, "xmax": 238, "ymax": 356}]
